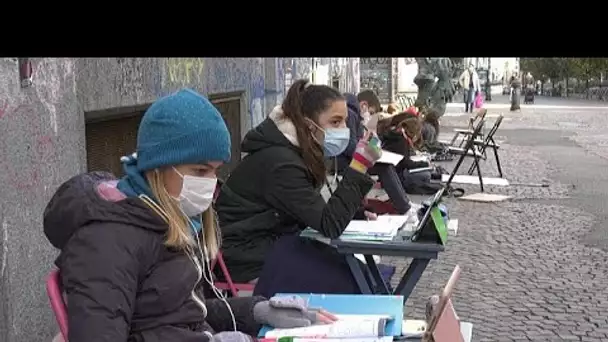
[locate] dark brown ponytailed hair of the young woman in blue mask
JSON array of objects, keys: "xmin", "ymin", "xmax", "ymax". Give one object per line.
[{"xmin": 281, "ymin": 79, "xmax": 344, "ymax": 186}]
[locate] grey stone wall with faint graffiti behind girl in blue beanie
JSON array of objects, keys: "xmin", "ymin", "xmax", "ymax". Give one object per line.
[{"xmin": 0, "ymin": 58, "xmax": 284, "ymax": 342}]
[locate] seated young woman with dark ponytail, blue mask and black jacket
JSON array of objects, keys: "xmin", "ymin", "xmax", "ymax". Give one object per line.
[{"xmin": 216, "ymin": 80, "xmax": 381, "ymax": 294}]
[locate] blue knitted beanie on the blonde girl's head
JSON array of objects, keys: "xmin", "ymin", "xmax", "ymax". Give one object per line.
[{"xmin": 137, "ymin": 89, "xmax": 230, "ymax": 172}]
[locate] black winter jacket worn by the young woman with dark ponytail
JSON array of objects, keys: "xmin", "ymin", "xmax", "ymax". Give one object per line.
[{"xmin": 216, "ymin": 108, "xmax": 374, "ymax": 282}]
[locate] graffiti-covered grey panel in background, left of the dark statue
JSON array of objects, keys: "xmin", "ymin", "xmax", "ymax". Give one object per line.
[{"xmin": 359, "ymin": 57, "xmax": 392, "ymax": 103}]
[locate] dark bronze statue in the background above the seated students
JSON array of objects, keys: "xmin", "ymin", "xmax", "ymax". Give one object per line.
[{"xmin": 414, "ymin": 57, "xmax": 456, "ymax": 116}]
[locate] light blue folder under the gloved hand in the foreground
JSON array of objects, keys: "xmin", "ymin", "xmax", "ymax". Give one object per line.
[{"xmin": 258, "ymin": 293, "xmax": 404, "ymax": 337}]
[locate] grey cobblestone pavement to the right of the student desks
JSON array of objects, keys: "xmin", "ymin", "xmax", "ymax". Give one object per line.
[{"xmin": 383, "ymin": 97, "xmax": 608, "ymax": 341}]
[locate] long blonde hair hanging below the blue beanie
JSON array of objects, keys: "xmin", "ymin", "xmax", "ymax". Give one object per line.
[{"xmin": 146, "ymin": 170, "xmax": 220, "ymax": 260}]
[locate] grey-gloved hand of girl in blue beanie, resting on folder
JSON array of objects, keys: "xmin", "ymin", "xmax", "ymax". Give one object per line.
[{"xmin": 253, "ymin": 296, "xmax": 335, "ymax": 329}]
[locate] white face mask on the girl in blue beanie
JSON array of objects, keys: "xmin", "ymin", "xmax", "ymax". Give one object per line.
[{"xmin": 173, "ymin": 168, "xmax": 217, "ymax": 217}]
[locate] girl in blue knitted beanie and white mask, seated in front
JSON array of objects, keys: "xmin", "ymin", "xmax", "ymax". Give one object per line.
[{"xmin": 44, "ymin": 89, "xmax": 330, "ymax": 342}]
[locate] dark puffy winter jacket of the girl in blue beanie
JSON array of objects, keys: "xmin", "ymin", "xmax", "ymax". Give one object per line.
[{"xmin": 44, "ymin": 172, "xmax": 263, "ymax": 342}]
